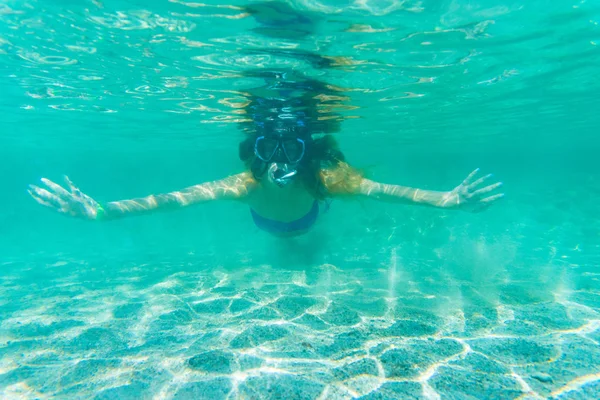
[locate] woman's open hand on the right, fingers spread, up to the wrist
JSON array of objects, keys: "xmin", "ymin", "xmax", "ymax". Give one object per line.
[{"xmin": 442, "ymin": 168, "xmax": 504, "ymax": 212}]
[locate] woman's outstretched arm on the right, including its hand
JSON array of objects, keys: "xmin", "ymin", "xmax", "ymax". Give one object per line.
[{"xmin": 358, "ymin": 169, "xmax": 504, "ymax": 212}]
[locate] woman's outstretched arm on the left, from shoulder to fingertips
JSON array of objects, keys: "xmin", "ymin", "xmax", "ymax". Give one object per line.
[{"xmin": 28, "ymin": 172, "xmax": 256, "ymax": 220}]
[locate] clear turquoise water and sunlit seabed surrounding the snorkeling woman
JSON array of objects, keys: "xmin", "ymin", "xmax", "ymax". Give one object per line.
[{"xmin": 0, "ymin": 0, "xmax": 600, "ymax": 399}]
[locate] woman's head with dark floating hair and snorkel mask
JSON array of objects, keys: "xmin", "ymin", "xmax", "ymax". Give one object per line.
[{"xmin": 239, "ymin": 71, "xmax": 352, "ymax": 197}]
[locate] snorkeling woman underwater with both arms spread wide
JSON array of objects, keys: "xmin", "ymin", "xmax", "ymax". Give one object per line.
[{"xmin": 29, "ymin": 4, "xmax": 503, "ymax": 236}]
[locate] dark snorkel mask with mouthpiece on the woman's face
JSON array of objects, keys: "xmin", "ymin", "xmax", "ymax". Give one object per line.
[{"xmin": 254, "ymin": 132, "xmax": 306, "ymax": 187}]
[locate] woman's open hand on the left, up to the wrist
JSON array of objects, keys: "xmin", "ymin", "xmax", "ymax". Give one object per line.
[{"xmin": 28, "ymin": 176, "xmax": 102, "ymax": 220}]
